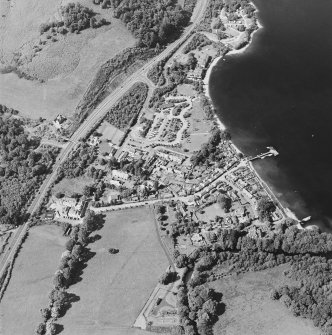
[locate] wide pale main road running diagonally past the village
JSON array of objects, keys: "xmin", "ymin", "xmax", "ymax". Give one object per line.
[{"xmin": 0, "ymin": 0, "xmax": 209, "ymax": 275}]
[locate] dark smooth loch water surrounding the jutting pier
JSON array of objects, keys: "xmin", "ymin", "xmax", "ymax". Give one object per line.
[{"xmin": 209, "ymin": 0, "xmax": 332, "ymax": 232}]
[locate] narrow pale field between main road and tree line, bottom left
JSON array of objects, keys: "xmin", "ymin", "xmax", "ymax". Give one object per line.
[{"xmin": 0, "ymin": 226, "xmax": 66, "ymax": 335}]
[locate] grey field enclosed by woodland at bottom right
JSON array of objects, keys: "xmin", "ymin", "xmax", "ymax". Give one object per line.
[{"xmin": 211, "ymin": 265, "xmax": 320, "ymax": 335}]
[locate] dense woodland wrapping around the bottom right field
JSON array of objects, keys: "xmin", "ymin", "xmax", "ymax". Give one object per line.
[{"xmin": 173, "ymin": 220, "xmax": 332, "ymax": 335}]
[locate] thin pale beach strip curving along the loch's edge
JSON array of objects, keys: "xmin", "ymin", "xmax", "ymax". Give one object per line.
[{"xmin": 203, "ymin": 2, "xmax": 306, "ymax": 229}]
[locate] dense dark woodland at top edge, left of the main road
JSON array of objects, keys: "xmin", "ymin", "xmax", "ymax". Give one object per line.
[{"xmin": 111, "ymin": 0, "xmax": 191, "ymax": 48}]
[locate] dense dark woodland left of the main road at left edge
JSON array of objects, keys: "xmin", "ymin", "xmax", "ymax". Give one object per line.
[{"xmin": 0, "ymin": 114, "xmax": 58, "ymax": 225}]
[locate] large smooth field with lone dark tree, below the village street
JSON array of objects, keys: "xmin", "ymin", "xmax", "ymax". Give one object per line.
[{"xmin": 59, "ymin": 208, "xmax": 168, "ymax": 335}]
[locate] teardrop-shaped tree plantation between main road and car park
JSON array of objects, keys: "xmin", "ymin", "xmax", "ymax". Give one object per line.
[{"xmin": 106, "ymin": 83, "xmax": 149, "ymax": 130}]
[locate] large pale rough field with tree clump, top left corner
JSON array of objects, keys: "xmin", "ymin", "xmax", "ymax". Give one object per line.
[{"xmin": 0, "ymin": 0, "xmax": 135, "ymax": 119}]
